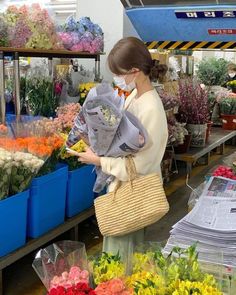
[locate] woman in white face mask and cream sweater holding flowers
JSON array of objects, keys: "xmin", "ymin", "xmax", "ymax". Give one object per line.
[{"xmin": 75, "ymin": 37, "xmax": 168, "ymax": 261}]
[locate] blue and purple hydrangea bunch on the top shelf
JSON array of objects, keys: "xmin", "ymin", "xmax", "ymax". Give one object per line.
[{"xmin": 58, "ymin": 16, "xmax": 104, "ymax": 53}]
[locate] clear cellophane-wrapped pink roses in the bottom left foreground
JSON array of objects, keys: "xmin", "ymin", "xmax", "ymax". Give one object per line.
[{"xmin": 32, "ymin": 241, "xmax": 89, "ymax": 294}]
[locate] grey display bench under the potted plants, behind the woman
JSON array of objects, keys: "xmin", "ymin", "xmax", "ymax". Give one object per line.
[{"xmin": 175, "ymin": 127, "xmax": 236, "ymax": 175}]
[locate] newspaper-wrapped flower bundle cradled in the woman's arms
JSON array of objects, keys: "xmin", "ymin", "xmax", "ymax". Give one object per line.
[{"xmin": 67, "ymin": 83, "xmax": 147, "ymax": 192}]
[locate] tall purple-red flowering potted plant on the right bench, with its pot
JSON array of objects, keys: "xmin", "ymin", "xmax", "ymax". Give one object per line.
[{"xmin": 178, "ymin": 79, "xmax": 209, "ymax": 147}]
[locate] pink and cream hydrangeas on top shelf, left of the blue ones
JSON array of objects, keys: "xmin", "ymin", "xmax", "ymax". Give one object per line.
[{"xmin": 4, "ymin": 3, "xmax": 63, "ymax": 49}]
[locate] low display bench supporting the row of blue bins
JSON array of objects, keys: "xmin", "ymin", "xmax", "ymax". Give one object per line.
[{"xmin": 0, "ymin": 208, "xmax": 94, "ymax": 295}]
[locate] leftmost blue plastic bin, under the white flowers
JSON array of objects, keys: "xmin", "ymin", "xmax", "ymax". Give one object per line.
[{"xmin": 0, "ymin": 191, "xmax": 29, "ymax": 256}]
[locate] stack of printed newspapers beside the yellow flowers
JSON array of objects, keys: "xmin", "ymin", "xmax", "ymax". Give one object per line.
[{"xmin": 164, "ymin": 177, "xmax": 236, "ymax": 267}]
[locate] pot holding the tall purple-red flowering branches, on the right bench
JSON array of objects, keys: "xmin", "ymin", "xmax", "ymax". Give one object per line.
[{"xmin": 187, "ymin": 124, "xmax": 207, "ymax": 147}]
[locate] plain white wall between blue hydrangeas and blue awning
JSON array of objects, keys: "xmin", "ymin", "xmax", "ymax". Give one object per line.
[{"xmin": 77, "ymin": 0, "xmax": 124, "ymax": 80}]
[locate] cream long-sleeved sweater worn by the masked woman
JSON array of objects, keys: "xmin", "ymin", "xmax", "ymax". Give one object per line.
[{"xmin": 101, "ymin": 90, "xmax": 168, "ymax": 191}]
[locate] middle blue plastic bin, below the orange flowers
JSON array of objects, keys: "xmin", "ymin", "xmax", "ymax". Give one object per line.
[{"xmin": 27, "ymin": 165, "xmax": 68, "ymax": 238}]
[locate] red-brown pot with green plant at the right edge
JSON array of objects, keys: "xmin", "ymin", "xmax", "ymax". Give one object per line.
[{"xmin": 219, "ymin": 96, "xmax": 236, "ymax": 130}]
